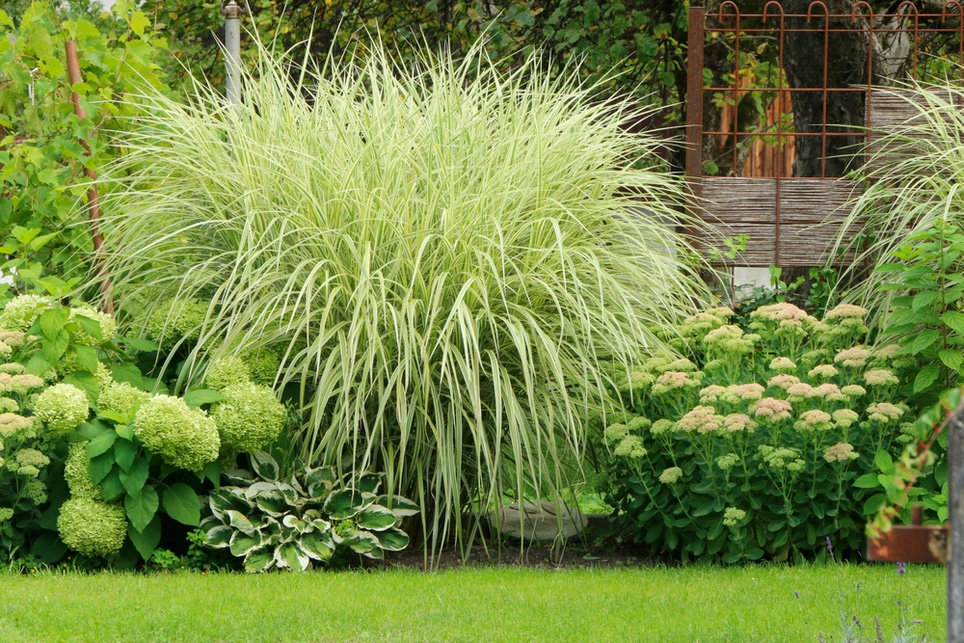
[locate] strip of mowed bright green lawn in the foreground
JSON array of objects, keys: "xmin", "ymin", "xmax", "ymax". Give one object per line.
[{"xmin": 0, "ymin": 565, "xmax": 946, "ymax": 643}]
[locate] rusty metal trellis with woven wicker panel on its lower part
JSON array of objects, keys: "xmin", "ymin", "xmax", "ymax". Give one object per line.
[{"xmin": 686, "ymin": 0, "xmax": 964, "ymax": 267}]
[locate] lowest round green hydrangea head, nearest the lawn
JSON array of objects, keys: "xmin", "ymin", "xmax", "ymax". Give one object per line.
[{"xmin": 57, "ymin": 498, "xmax": 127, "ymax": 557}]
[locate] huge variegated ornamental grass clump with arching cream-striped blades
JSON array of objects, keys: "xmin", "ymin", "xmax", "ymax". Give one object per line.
[{"xmin": 92, "ymin": 43, "xmax": 703, "ymax": 547}]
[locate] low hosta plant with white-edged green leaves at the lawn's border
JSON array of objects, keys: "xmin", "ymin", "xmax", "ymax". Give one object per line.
[{"xmin": 201, "ymin": 451, "xmax": 418, "ymax": 572}]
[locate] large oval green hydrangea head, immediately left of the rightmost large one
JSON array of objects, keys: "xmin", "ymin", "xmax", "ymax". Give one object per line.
[{"xmin": 134, "ymin": 395, "xmax": 221, "ymax": 471}]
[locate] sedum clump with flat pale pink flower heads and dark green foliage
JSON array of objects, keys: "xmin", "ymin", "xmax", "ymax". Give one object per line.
[{"xmin": 603, "ymin": 303, "xmax": 913, "ymax": 563}]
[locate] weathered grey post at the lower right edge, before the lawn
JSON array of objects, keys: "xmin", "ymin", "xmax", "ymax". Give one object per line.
[{"xmin": 947, "ymin": 409, "xmax": 964, "ymax": 643}]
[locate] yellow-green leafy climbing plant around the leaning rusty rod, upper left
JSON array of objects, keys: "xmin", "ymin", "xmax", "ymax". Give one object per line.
[{"xmin": 0, "ymin": 0, "xmax": 167, "ymax": 300}]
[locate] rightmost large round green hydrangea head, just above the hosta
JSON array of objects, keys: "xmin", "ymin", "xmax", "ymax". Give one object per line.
[{"xmin": 211, "ymin": 383, "xmax": 287, "ymax": 453}]
